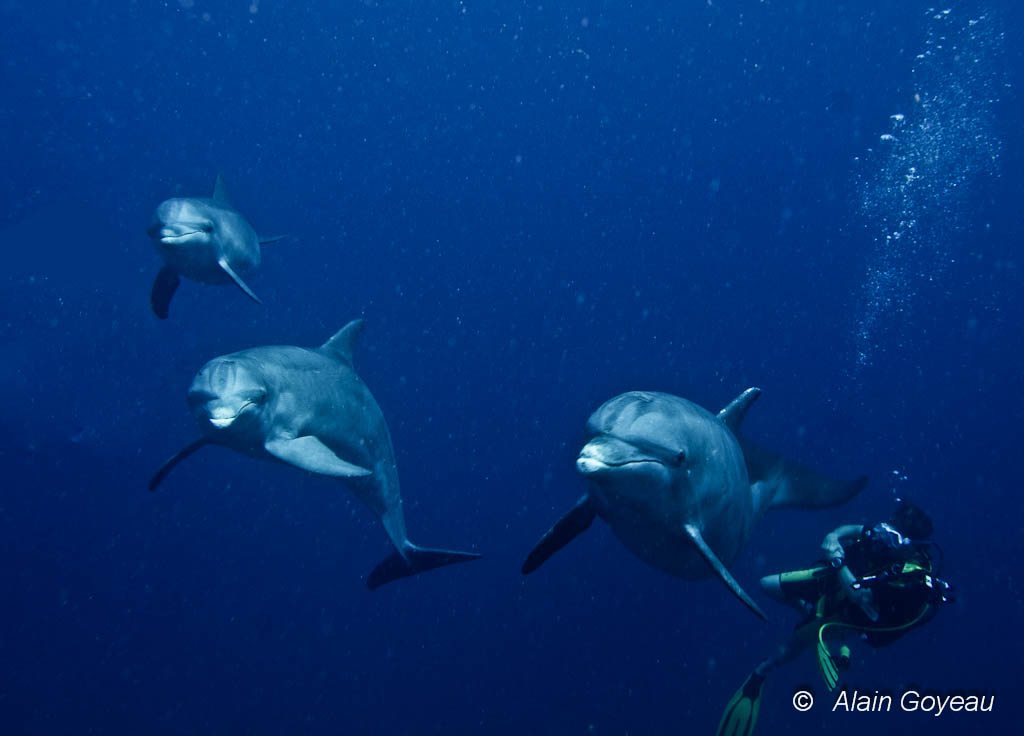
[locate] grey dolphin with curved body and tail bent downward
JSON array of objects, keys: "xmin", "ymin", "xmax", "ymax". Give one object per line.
[{"xmin": 150, "ymin": 319, "xmax": 479, "ymax": 589}]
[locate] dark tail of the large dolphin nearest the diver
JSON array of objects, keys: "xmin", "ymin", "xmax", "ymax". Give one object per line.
[{"xmin": 739, "ymin": 438, "xmax": 867, "ymax": 513}]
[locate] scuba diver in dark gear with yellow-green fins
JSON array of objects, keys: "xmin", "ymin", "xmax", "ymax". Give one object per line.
[{"xmin": 717, "ymin": 500, "xmax": 953, "ymax": 736}]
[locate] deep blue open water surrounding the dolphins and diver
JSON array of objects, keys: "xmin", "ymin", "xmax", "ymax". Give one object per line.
[{"xmin": 0, "ymin": 0, "xmax": 1024, "ymax": 735}]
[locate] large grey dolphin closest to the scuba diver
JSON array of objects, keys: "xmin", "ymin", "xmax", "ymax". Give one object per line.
[{"xmin": 522, "ymin": 388, "xmax": 867, "ymax": 618}]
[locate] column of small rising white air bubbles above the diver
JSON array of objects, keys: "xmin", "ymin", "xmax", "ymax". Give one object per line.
[{"xmin": 854, "ymin": 9, "xmax": 1005, "ymax": 370}]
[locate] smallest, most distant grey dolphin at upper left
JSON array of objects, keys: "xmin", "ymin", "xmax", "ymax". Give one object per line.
[{"xmin": 147, "ymin": 174, "xmax": 281, "ymax": 319}]
